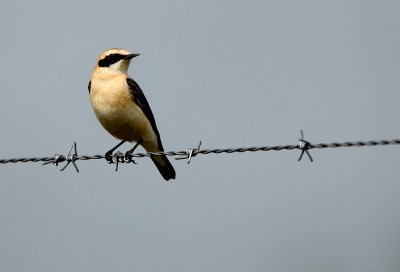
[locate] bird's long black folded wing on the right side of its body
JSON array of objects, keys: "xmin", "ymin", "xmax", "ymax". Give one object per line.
[{"xmin": 126, "ymin": 77, "xmax": 164, "ymax": 151}]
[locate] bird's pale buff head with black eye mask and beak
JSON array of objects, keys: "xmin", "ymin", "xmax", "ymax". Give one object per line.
[{"xmin": 96, "ymin": 48, "xmax": 140, "ymax": 74}]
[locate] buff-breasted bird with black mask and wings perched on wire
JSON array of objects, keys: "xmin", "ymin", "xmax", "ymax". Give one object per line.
[{"xmin": 88, "ymin": 48, "xmax": 176, "ymax": 181}]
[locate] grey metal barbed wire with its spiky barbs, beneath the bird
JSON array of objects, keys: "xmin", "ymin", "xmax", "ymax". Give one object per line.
[{"xmin": 0, "ymin": 130, "xmax": 400, "ymax": 172}]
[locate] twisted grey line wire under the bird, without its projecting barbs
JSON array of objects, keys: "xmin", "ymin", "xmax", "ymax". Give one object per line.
[{"xmin": 0, "ymin": 139, "xmax": 400, "ymax": 165}]
